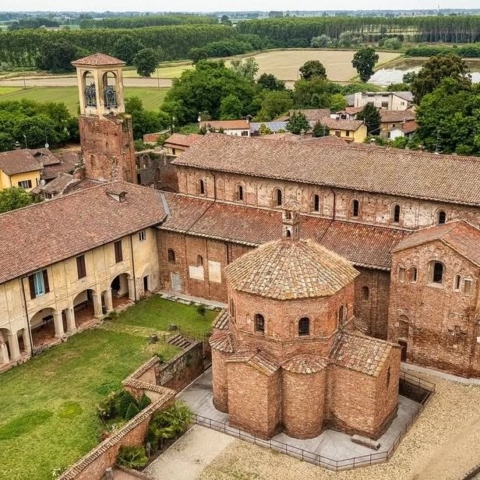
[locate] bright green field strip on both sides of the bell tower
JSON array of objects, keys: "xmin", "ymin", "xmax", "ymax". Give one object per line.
[{"xmin": 0, "ymin": 87, "xmax": 168, "ymax": 114}]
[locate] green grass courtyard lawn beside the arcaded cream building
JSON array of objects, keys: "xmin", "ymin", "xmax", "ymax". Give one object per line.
[{"xmin": 0, "ymin": 296, "xmax": 216, "ymax": 480}]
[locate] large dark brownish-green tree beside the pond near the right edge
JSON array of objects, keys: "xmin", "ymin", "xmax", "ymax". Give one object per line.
[{"xmin": 411, "ymin": 54, "xmax": 472, "ymax": 105}]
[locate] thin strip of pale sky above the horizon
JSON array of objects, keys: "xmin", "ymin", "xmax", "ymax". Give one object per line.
[{"xmin": 0, "ymin": 0, "xmax": 480, "ymax": 12}]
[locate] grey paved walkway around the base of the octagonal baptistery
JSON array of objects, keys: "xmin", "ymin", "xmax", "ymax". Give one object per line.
[{"xmin": 178, "ymin": 369, "xmax": 419, "ymax": 461}]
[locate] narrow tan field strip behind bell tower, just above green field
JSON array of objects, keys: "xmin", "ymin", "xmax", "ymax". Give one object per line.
[{"xmin": 0, "ymin": 77, "xmax": 172, "ymax": 88}]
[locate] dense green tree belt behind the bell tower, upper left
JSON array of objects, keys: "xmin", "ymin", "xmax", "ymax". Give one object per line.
[{"xmin": 0, "ymin": 25, "xmax": 236, "ymax": 67}]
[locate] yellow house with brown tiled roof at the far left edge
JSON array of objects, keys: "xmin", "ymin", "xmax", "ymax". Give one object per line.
[{"xmin": 0, "ymin": 149, "xmax": 43, "ymax": 191}]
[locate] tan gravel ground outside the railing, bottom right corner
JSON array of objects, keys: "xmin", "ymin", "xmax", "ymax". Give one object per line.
[{"xmin": 199, "ymin": 375, "xmax": 480, "ymax": 480}]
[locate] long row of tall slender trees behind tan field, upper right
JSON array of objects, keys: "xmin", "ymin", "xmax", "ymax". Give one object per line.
[{"xmin": 236, "ymin": 15, "xmax": 480, "ymax": 47}]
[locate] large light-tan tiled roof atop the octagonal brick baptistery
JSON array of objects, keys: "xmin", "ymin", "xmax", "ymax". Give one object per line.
[{"xmin": 225, "ymin": 239, "xmax": 359, "ymax": 300}]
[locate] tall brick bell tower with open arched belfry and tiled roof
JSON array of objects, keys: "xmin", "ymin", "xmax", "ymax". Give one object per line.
[{"xmin": 72, "ymin": 53, "xmax": 137, "ymax": 183}]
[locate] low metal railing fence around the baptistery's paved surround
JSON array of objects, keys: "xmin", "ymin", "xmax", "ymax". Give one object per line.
[{"xmin": 194, "ymin": 372, "xmax": 435, "ymax": 471}]
